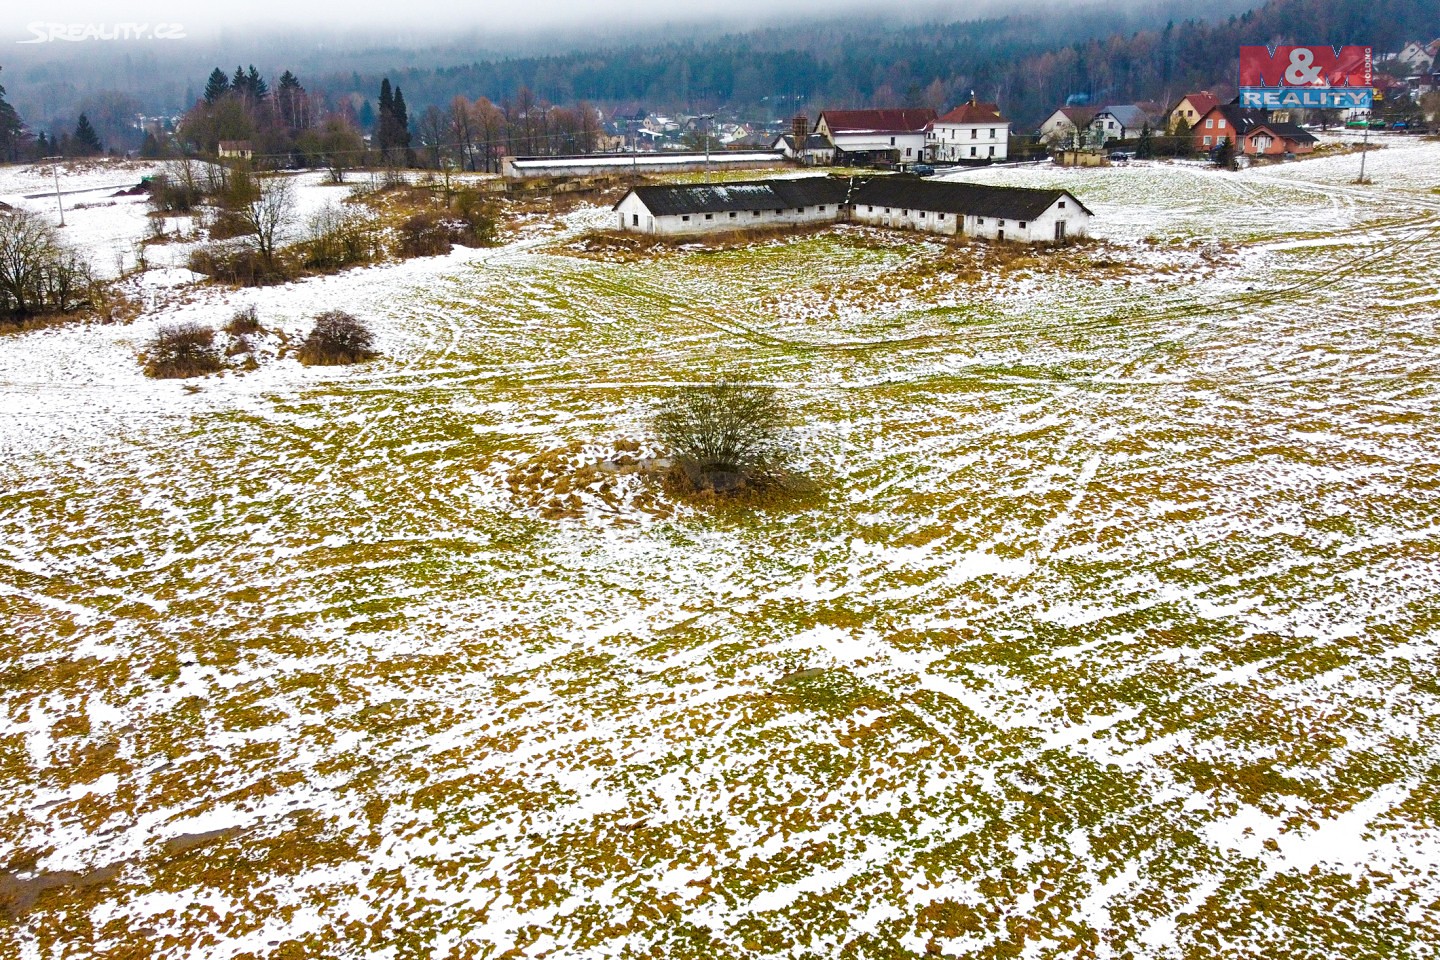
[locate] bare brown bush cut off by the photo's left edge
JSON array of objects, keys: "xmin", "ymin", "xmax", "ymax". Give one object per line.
[{"xmin": 0, "ymin": 210, "xmax": 95, "ymax": 317}]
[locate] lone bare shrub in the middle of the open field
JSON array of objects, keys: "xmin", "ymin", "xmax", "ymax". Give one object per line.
[{"xmin": 655, "ymin": 381, "xmax": 786, "ymax": 494}]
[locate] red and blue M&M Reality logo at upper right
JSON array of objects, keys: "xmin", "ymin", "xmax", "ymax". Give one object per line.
[{"xmin": 1240, "ymin": 46, "xmax": 1372, "ymax": 109}]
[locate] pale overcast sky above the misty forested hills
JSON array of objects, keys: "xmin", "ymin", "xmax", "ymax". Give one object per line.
[{"xmin": 0, "ymin": 0, "xmax": 989, "ymax": 42}]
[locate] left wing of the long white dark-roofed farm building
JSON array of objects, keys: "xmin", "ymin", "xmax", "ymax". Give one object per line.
[{"xmin": 615, "ymin": 177, "xmax": 850, "ymax": 236}]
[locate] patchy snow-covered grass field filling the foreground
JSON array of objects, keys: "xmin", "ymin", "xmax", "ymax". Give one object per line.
[{"xmin": 0, "ymin": 142, "xmax": 1440, "ymax": 960}]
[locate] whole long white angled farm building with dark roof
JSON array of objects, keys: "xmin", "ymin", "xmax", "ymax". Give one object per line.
[{"xmin": 615, "ymin": 177, "xmax": 1092, "ymax": 243}]
